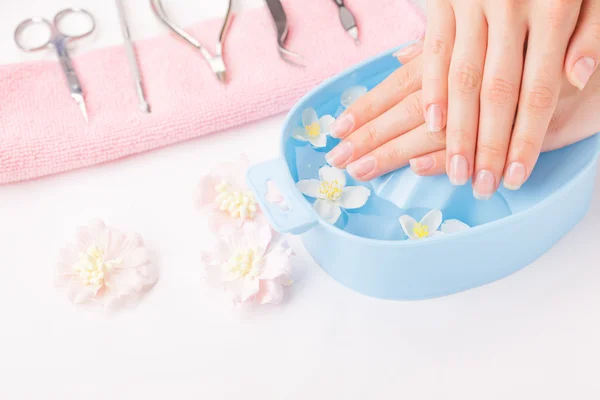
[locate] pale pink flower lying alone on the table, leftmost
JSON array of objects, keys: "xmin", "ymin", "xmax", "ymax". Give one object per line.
[{"xmin": 56, "ymin": 221, "xmax": 158, "ymax": 308}]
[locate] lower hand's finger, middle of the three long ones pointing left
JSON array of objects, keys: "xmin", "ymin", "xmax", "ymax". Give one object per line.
[{"xmin": 325, "ymin": 91, "xmax": 425, "ymax": 168}]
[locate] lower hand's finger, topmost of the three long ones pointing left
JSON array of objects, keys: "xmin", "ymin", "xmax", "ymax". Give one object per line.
[{"xmin": 331, "ymin": 56, "xmax": 422, "ymax": 139}]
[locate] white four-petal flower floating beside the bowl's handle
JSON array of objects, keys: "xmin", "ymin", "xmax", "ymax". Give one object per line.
[{"xmin": 296, "ymin": 166, "xmax": 371, "ymax": 224}]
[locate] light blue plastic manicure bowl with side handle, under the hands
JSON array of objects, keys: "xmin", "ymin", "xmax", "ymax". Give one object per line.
[{"xmin": 248, "ymin": 44, "xmax": 600, "ymax": 300}]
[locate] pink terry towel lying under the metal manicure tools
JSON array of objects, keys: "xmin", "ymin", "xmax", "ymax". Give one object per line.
[{"xmin": 0, "ymin": 0, "xmax": 425, "ymax": 184}]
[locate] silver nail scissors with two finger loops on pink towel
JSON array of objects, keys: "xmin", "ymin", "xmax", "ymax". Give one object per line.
[{"xmin": 14, "ymin": 8, "xmax": 96, "ymax": 123}]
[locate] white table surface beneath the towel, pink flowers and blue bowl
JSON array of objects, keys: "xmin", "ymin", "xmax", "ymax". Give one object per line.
[{"xmin": 0, "ymin": 0, "xmax": 600, "ymax": 400}]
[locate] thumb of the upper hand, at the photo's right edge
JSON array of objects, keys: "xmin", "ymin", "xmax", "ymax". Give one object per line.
[{"xmin": 565, "ymin": 1, "xmax": 600, "ymax": 90}]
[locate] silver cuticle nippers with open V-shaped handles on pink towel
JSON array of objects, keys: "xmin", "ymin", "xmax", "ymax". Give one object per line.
[{"xmin": 150, "ymin": 0, "xmax": 233, "ymax": 83}]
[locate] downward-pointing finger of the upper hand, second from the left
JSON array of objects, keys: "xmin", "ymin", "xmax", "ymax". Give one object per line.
[{"xmin": 446, "ymin": 0, "xmax": 488, "ymax": 185}]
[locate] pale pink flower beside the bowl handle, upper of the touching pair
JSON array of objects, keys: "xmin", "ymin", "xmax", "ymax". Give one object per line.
[{"xmin": 195, "ymin": 154, "xmax": 262, "ymax": 231}]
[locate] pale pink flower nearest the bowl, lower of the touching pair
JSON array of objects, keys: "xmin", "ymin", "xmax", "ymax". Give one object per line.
[{"xmin": 202, "ymin": 223, "xmax": 293, "ymax": 304}]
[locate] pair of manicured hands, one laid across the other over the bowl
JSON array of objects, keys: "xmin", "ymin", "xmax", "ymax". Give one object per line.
[{"xmin": 328, "ymin": 0, "xmax": 600, "ymax": 198}]
